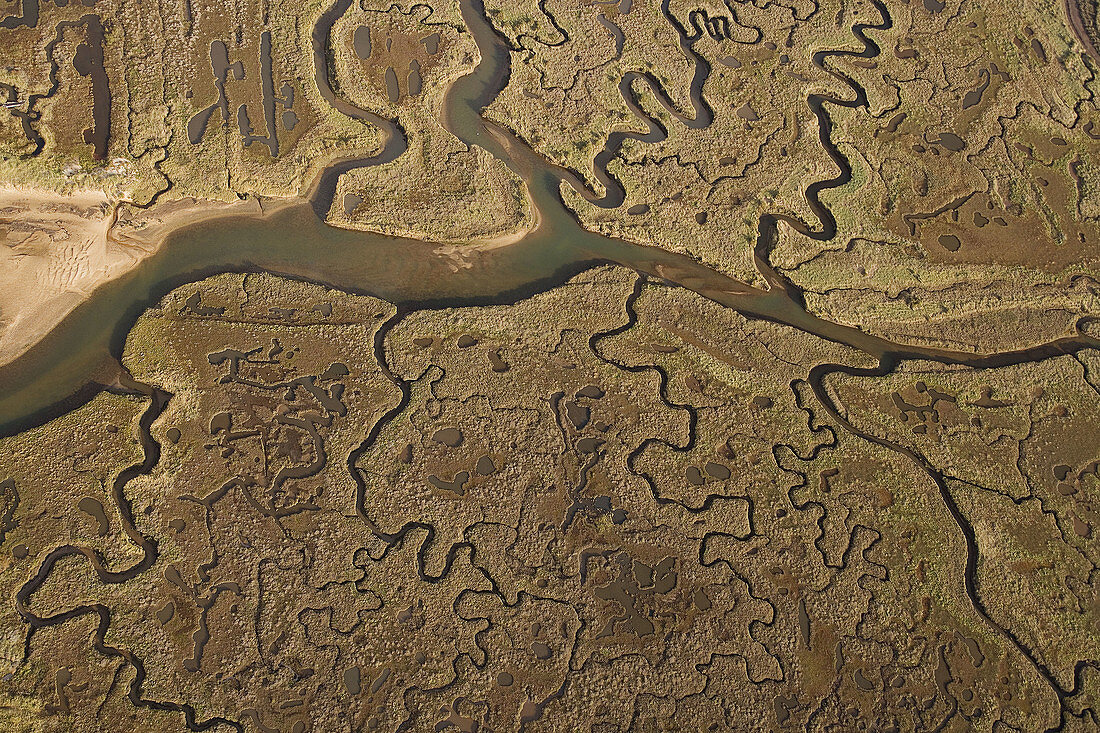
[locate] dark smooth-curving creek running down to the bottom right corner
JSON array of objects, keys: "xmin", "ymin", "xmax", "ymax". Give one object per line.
[{"xmin": 809, "ymin": 350, "xmax": 1100, "ymax": 733}]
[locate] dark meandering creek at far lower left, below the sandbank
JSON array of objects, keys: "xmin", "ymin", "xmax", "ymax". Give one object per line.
[{"xmin": 15, "ymin": 380, "xmax": 244, "ymax": 731}]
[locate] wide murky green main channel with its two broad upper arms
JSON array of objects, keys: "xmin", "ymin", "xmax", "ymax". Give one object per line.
[{"xmin": 0, "ymin": 0, "xmax": 1012, "ymax": 435}]
